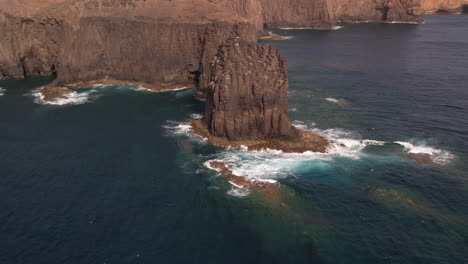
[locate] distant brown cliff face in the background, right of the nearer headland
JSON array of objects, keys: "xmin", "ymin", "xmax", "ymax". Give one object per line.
[{"xmin": 210, "ymin": 0, "xmax": 422, "ymax": 29}]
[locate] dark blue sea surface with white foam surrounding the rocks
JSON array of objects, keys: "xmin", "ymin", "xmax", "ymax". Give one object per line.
[{"xmin": 0, "ymin": 15, "xmax": 468, "ymax": 264}]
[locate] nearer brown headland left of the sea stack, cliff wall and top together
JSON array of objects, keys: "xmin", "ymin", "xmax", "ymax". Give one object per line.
[{"xmin": 0, "ymin": 0, "xmax": 257, "ymax": 86}]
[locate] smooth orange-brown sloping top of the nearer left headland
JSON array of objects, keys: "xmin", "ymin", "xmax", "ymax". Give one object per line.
[{"xmin": 0, "ymin": 0, "xmax": 246, "ymax": 25}]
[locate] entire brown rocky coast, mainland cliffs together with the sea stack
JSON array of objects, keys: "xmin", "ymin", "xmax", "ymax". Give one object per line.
[{"xmin": 0, "ymin": 0, "xmax": 464, "ymax": 152}]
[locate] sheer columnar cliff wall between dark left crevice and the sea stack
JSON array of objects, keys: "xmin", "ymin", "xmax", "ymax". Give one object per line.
[{"xmin": 55, "ymin": 18, "xmax": 255, "ymax": 86}]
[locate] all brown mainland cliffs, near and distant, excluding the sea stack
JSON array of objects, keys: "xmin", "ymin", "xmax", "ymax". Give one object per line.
[{"xmin": 0, "ymin": 0, "xmax": 432, "ymax": 82}]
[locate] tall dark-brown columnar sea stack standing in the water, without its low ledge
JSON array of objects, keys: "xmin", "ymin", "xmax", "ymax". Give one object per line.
[{"xmin": 205, "ymin": 39, "xmax": 296, "ymax": 140}]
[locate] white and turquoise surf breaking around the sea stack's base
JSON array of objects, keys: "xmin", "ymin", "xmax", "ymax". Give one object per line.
[{"xmin": 163, "ymin": 115, "xmax": 385, "ymax": 191}]
